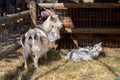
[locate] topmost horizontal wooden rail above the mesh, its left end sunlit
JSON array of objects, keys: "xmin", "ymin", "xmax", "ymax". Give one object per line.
[{"xmin": 38, "ymin": 3, "xmax": 120, "ymax": 9}]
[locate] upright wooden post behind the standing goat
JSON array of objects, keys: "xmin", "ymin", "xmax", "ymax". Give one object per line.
[{"xmin": 29, "ymin": 1, "xmax": 37, "ymax": 27}]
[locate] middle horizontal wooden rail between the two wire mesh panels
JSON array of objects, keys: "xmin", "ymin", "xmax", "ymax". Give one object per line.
[{"xmin": 61, "ymin": 28, "xmax": 120, "ymax": 34}]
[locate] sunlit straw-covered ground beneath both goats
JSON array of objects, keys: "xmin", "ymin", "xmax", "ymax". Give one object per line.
[{"xmin": 0, "ymin": 48, "xmax": 120, "ymax": 80}]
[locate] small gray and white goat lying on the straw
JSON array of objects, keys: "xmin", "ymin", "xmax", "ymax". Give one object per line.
[{"xmin": 65, "ymin": 42, "xmax": 103, "ymax": 61}]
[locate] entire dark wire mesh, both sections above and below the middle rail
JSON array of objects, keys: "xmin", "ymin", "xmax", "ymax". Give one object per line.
[{"xmin": 58, "ymin": 7, "xmax": 120, "ymax": 48}]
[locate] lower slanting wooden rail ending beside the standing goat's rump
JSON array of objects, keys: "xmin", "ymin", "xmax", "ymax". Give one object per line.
[{"xmin": 0, "ymin": 41, "xmax": 21, "ymax": 60}]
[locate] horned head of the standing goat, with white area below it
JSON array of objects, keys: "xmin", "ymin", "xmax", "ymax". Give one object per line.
[{"xmin": 41, "ymin": 8, "xmax": 63, "ymax": 42}]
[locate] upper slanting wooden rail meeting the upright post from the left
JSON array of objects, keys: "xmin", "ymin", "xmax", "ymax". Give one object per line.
[{"xmin": 0, "ymin": 10, "xmax": 30, "ymax": 24}]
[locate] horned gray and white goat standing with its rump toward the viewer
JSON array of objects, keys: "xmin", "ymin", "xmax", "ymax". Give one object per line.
[{"xmin": 21, "ymin": 8, "xmax": 62, "ymax": 68}]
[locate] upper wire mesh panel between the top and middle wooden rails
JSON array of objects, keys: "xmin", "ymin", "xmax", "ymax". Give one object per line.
[{"xmin": 59, "ymin": 8, "xmax": 120, "ymax": 28}]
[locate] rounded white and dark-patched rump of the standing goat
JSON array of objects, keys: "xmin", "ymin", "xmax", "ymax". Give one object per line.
[{"xmin": 21, "ymin": 28, "xmax": 48, "ymax": 57}]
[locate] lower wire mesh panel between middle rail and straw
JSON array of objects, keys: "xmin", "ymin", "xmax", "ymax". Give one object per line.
[{"xmin": 58, "ymin": 33, "xmax": 120, "ymax": 49}]
